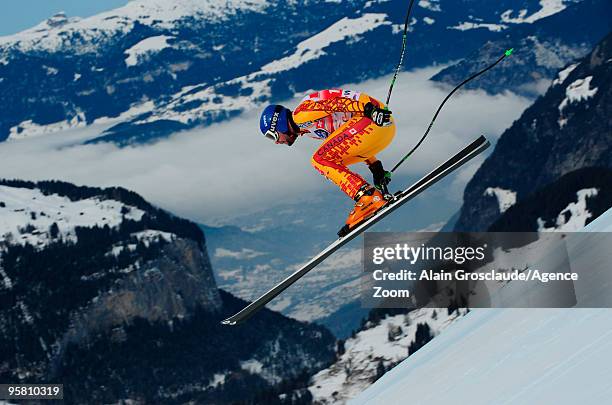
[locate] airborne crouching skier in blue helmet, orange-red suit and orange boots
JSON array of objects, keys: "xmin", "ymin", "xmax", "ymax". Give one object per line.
[{"xmin": 259, "ymin": 89, "xmax": 395, "ymax": 236}]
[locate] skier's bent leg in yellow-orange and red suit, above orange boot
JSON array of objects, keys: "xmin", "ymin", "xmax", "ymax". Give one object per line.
[{"xmin": 311, "ymin": 117, "xmax": 395, "ymax": 198}]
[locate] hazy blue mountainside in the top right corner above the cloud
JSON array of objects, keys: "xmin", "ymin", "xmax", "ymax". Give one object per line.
[{"xmin": 432, "ymin": 0, "xmax": 612, "ymax": 97}]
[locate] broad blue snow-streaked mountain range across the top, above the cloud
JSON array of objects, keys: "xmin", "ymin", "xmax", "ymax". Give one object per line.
[{"xmin": 0, "ymin": 0, "xmax": 582, "ymax": 144}]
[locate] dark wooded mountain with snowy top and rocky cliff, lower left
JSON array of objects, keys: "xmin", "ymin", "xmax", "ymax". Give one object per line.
[{"xmin": 0, "ymin": 180, "xmax": 335, "ymax": 403}]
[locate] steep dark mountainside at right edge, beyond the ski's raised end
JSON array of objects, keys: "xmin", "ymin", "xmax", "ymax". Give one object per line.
[{"xmin": 455, "ymin": 29, "xmax": 612, "ymax": 230}]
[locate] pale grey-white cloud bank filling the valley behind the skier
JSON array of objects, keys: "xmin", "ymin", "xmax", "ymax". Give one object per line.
[{"xmin": 0, "ymin": 68, "xmax": 530, "ymax": 223}]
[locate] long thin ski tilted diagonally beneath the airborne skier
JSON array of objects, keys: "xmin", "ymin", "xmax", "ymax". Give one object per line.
[{"xmin": 221, "ymin": 135, "xmax": 490, "ymax": 325}]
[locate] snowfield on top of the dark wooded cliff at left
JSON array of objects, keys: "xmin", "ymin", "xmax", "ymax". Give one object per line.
[{"xmin": 0, "ymin": 186, "xmax": 144, "ymax": 246}]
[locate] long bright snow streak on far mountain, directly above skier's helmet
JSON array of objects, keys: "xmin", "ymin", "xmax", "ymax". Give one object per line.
[{"xmin": 261, "ymin": 13, "xmax": 391, "ymax": 73}]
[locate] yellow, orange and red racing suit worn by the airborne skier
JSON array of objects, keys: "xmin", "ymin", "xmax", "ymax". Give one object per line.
[{"xmin": 293, "ymin": 89, "xmax": 395, "ymax": 198}]
